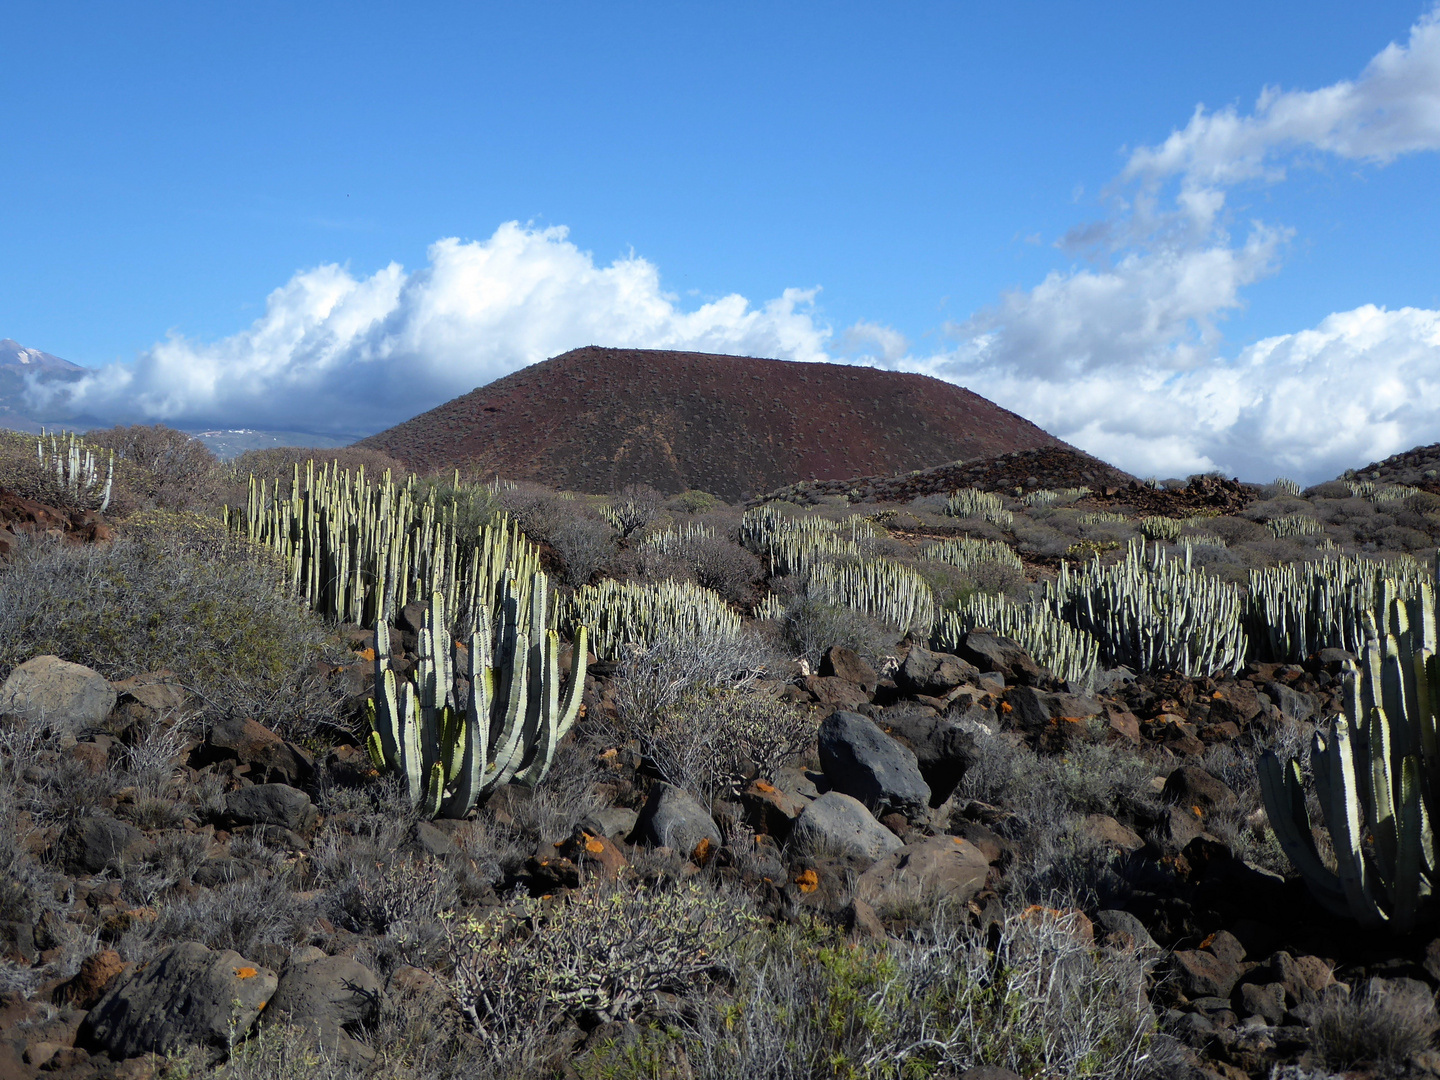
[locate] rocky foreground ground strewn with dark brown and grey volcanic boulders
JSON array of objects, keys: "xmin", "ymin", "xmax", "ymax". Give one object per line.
[{"xmin": 0, "ymin": 616, "xmax": 1440, "ymax": 1077}]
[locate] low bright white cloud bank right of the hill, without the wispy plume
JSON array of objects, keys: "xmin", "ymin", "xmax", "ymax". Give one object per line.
[{"xmin": 901, "ymin": 305, "xmax": 1440, "ymax": 484}]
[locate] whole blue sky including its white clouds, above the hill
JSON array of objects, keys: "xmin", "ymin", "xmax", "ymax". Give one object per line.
[{"xmin": 0, "ymin": 0, "xmax": 1440, "ymax": 478}]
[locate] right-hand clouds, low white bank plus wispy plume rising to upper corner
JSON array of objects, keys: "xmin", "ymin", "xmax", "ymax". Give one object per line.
[{"xmin": 873, "ymin": 0, "xmax": 1440, "ymax": 482}]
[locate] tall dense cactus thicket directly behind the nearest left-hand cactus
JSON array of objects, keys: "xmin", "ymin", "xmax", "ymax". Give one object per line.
[{"xmin": 233, "ymin": 461, "xmax": 540, "ymax": 628}]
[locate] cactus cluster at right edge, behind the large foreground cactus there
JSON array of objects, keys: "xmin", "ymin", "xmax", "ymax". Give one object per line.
[{"xmin": 1246, "ymin": 556, "xmax": 1427, "ymax": 664}]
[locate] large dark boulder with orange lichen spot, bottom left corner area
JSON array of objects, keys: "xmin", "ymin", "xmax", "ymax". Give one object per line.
[{"xmin": 75, "ymin": 942, "xmax": 278, "ymax": 1058}]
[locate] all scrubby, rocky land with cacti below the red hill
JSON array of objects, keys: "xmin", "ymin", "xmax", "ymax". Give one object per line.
[{"xmin": 0, "ymin": 428, "xmax": 1440, "ymax": 1080}]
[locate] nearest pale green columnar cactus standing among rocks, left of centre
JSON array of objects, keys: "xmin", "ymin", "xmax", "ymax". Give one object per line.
[{"xmin": 369, "ymin": 573, "xmax": 589, "ymax": 818}]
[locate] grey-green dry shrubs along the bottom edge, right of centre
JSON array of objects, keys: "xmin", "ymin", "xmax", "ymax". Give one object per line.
[{"xmin": 601, "ymin": 909, "xmax": 1155, "ymax": 1080}]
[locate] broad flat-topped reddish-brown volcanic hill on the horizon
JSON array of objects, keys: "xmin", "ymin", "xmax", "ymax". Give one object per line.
[{"xmin": 357, "ymin": 347, "xmax": 1066, "ymax": 501}]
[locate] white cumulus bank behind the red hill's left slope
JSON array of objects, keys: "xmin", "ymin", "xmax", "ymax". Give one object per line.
[{"xmin": 32, "ymin": 222, "xmax": 829, "ymax": 433}]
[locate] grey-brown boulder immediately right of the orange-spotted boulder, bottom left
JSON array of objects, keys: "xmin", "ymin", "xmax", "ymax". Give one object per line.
[{"xmin": 265, "ymin": 950, "xmax": 384, "ymax": 1061}]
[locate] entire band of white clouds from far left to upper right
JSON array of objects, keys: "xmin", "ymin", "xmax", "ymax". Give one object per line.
[{"xmin": 35, "ymin": 6, "xmax": 1440, "ymax": 482}]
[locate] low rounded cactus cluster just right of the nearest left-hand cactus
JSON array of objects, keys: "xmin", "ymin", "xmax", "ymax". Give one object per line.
[{"xmin": 560, "ymin": 579, "xmax": 740, "ymax": 661}]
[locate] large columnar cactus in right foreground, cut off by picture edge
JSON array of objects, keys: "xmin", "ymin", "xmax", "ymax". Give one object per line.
[{"xmin": 1259, "ymin": 583, "xmax": 1440, "ymax": 933}]
